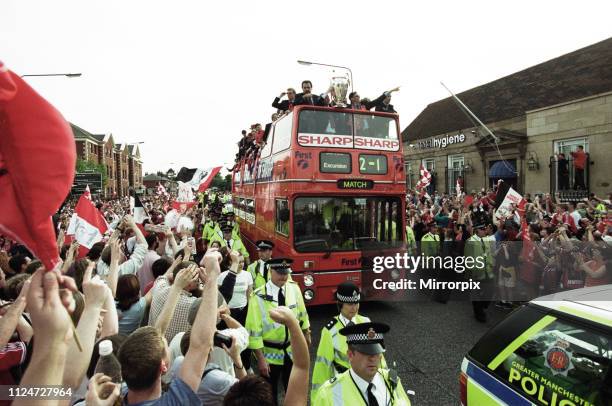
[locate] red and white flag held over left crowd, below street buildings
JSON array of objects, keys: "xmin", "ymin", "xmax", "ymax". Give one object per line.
[{"xmin": 66, "ymin": 191, "xmax": 108, "ymax": 249}]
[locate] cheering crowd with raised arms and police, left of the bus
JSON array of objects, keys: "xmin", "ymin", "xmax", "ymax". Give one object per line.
[{"xmin": 0, "ymin": 192, "xmax": 416, "ymax": 405}]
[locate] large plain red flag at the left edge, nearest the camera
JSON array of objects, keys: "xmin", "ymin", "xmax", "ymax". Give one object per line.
[{"xmin": 0, "ymin": 62, "xmax": 76, "ymax": 270}]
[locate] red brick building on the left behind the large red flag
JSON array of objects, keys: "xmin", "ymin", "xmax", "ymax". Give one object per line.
[{"xmin": 70, "ymin": 123, "xmax": 142, "ymax": 197}]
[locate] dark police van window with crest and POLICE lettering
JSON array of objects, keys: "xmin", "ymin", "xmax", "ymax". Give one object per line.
[{"xmin": 493, "ymin": 310, "xmax": 612, "ymax": 405}]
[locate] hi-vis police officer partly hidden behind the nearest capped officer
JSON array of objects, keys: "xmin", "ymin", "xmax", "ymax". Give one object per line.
[{"xmin": 310, "ymin": 281, "xmax": 384, "ymax": 400}]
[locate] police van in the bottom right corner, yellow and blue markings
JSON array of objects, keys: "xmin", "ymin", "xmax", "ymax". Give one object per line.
[{"xmin": 459, "ymin": 285, "xmax": 612, "ymax": 406}]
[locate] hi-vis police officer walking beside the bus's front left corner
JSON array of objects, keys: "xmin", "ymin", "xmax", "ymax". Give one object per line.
[{"xmin": 245, "ymin": 258, "xmax": 310, "ymax": 400}]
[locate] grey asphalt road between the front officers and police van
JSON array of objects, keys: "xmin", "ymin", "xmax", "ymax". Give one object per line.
[{"xmin": 308, "ymin": 297, "xmax": 508, "ymax": 406}]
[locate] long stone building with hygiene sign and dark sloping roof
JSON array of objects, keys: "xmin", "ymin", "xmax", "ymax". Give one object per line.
[{"xmin": 402, "ymin": 38, "xmax": 612, "ymax": 200}]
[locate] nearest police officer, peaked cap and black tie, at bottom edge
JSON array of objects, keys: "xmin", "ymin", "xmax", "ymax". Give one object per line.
[{"xmin": 313, "ymin": 322, "xmax": 410, "ymax": 406}]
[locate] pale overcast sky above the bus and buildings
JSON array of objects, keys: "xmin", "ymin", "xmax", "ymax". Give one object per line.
[{"xmin": 0, "ymin": 0, "xmax": 612, "ymax": 172}]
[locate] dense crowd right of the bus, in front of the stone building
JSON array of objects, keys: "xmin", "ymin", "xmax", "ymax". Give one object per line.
[{"xmin": 406, "ymin": 186, "xmax": 612, "ymax": 322}]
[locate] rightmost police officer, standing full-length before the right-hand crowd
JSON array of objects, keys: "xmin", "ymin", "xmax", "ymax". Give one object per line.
[{"xmin": 464, "ymin": 223, "xmax": 494, "ymax": 323}]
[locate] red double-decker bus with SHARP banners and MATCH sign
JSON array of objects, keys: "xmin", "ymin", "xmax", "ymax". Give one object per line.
[{"xmin": 232, "ymin": 106, "xmax": 406, "ymax": 305}]
